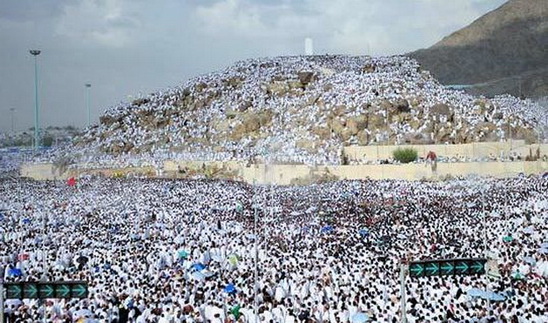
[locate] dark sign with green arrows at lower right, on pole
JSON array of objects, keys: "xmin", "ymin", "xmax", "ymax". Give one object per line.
[{"xmin": 409, "ymin": 258, "xmax": 487, "ymax": 277}]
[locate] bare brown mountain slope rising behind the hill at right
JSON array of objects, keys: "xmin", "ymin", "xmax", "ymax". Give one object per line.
[{"xmin": 409, "ymin": 0, "xmax": 548, "ymax": 97}]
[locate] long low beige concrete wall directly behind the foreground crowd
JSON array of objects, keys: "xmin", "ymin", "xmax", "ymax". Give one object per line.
[{"xmin": 21, "ymin": 155, "xmax": 548, "ymax": 185}]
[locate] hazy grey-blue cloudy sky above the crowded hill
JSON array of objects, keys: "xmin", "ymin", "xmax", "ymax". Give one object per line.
[{"xmin": 0, "ymin": 0, "xmax": 506, "ymax": 131}]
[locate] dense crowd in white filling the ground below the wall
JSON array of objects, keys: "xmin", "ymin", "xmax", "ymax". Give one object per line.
[{"xmin": 0, "ymin": 155, "xmax": 548, "ymax": 323}]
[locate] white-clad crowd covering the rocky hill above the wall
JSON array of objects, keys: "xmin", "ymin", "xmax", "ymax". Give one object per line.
[{"xmin": 46, "ymin": 55, "xmax": 548, "ymax": 167}]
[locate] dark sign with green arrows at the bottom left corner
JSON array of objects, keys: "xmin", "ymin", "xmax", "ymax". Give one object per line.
[{"xmin": 5, "ymin": 281, "xmax": 88, "ymax": 299}]
